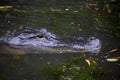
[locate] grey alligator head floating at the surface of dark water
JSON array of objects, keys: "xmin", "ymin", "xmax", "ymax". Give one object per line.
[{"xmin": 0, "ymin": 27, "xmax": 101, "ymax": 53}]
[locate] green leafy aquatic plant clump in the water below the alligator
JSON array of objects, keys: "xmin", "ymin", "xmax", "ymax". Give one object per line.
[{"xmin": 43, "ymin": 57, "xmax": 97, "ymax": 80}]
